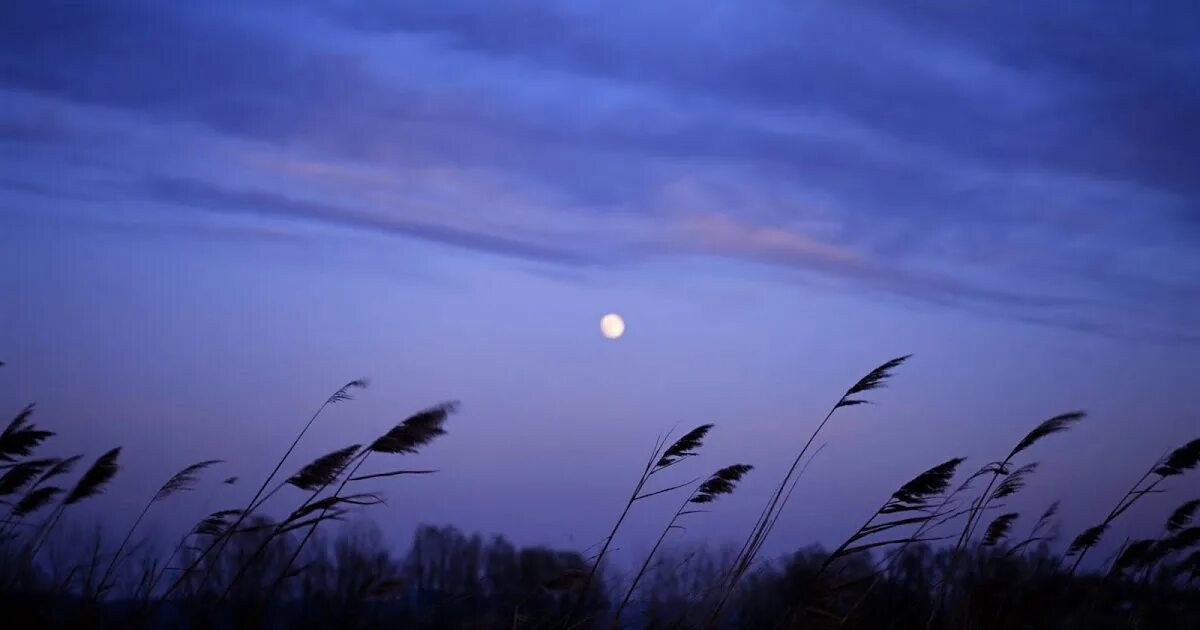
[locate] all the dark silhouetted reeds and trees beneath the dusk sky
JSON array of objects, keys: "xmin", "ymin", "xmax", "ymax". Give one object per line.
[{"xmin": 0, "ymin": 358, "xmax": 1200, "ymax": 629}]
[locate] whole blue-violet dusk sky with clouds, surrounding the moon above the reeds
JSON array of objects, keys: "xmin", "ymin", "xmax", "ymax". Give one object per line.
[{"xmin": 0, "ymin": 0, "xmax": 1200, "ymax": 566}]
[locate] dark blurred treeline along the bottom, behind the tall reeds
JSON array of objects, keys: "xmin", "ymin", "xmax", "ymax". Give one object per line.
[{"xmin": 7, "ymin": 524, "xmax": 1200, "ymax": 630}]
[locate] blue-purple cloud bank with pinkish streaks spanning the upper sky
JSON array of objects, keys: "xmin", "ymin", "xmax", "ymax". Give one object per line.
[{"xmin": 0, "ymin": 0, "xmax": 1200, "ymax": 331}]
